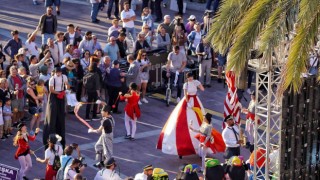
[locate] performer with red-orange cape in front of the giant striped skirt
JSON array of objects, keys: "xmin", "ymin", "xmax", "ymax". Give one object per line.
[{"xmin": 189, "ymin": 113, "xmax": 226, "ymax": 171}]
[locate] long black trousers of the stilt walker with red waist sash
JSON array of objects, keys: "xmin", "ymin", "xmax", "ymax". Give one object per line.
[{"xmin": 42, "ymin": 93, "xmax": 66, "ymax": 149}]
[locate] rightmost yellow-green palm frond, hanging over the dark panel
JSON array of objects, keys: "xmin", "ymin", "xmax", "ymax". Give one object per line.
[{"xmin": 279, "ymin": 1, "xmax": 320, "ymax": 93}]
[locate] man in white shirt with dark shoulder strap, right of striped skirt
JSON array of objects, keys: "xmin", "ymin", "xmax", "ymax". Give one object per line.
[{"xmin": 222, "ymin": 115, "xmax": 243, "ymax": 159}]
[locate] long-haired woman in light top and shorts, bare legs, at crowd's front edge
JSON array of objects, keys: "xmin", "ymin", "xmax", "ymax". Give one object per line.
[{"xmin": 137, "ymin": 49, "xmax": 151, "ymax": 104}]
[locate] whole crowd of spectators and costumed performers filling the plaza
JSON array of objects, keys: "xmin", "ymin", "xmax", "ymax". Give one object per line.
[{"xmin": 0, "ymin": 0, "xmax": 288, "ymax": 180}]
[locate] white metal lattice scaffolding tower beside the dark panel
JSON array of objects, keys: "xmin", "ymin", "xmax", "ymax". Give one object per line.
[{"xmin": 248, "ymin": 53, "xmax": 282, "ymax": 180}]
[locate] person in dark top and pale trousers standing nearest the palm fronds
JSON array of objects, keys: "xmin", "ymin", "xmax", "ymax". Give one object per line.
[{"xmin": 196, "ymin": 39, "xmax": 213, "ymax": 88}]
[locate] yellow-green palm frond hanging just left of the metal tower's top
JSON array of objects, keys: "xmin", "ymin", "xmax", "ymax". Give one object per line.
[{"xmin": 227, "ymin": 0, "xmax": 277, "ymax": 74}]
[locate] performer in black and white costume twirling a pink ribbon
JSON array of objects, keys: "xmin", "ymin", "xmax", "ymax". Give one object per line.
[{"xmin": 88, "ymin": 105, "xmax": 115, "ymax": 164}]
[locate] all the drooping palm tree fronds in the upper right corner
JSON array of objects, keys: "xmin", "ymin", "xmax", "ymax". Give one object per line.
[{"xmin": 206, "ymin": 0, "xmax": 320, "ymax": 92}]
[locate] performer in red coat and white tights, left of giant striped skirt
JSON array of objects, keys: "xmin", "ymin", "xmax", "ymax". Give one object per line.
[{"xmin": 119, "ymin": 83, "xmax": 141, "ymax": 141}]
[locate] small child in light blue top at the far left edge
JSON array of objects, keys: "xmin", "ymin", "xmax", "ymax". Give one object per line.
[{"xmin": 2, "ymin": 98, "xmax": 13, "ymax": 136}]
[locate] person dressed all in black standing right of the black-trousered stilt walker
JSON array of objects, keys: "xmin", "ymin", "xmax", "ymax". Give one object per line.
[{"xmin": 83, "ymin": 63, "xmax": 101, "ymax": 121}]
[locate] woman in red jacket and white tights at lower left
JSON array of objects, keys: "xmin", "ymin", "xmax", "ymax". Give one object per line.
[{"xmin": 13, "ymin": 123, "xmax": 40, "ymax": 180}]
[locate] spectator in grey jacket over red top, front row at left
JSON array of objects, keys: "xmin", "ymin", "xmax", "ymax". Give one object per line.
[{"xmin": 7, "ymin": 66, "xmax": 26, "ymax": 127}]
